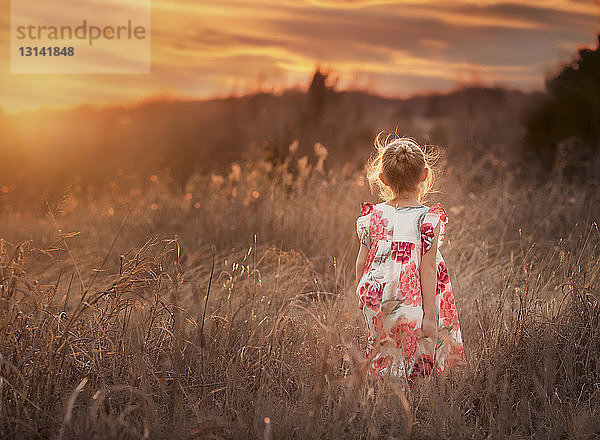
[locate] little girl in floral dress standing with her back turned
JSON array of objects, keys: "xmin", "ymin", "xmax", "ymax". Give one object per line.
[{"xmin": 356, "ymin": 136, "xmax": 465, "ymax": 379}]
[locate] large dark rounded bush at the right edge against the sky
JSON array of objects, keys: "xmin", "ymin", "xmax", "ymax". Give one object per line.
[{"xmin": 525, "ymin": 35, "xmax": 600, "ymax": 179}]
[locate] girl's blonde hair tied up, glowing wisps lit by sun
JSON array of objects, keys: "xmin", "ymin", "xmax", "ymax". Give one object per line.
[{"xmin": 367, "ymin": 133, "xmax": 437, "ymax": 202}]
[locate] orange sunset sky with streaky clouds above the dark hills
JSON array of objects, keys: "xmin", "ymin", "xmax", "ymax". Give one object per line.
[{"xmin": 0, "ymin": 0, "xmax": 600, "ymax": 112}]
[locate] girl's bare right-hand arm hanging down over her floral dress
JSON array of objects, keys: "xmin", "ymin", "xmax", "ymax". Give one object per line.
[{"xmin": 420, "ymin": 223, "xmax": 440, "ymax": 338}]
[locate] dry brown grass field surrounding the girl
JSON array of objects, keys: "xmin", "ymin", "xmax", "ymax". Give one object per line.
[{"xmin": 0, "ymin": 145, "xmax": 600, "ymax": 439}]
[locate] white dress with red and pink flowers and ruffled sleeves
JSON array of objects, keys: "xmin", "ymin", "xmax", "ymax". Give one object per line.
[{"xmin": 356, "ymin": 202, "xmax": 465, "ymax": 378}]
